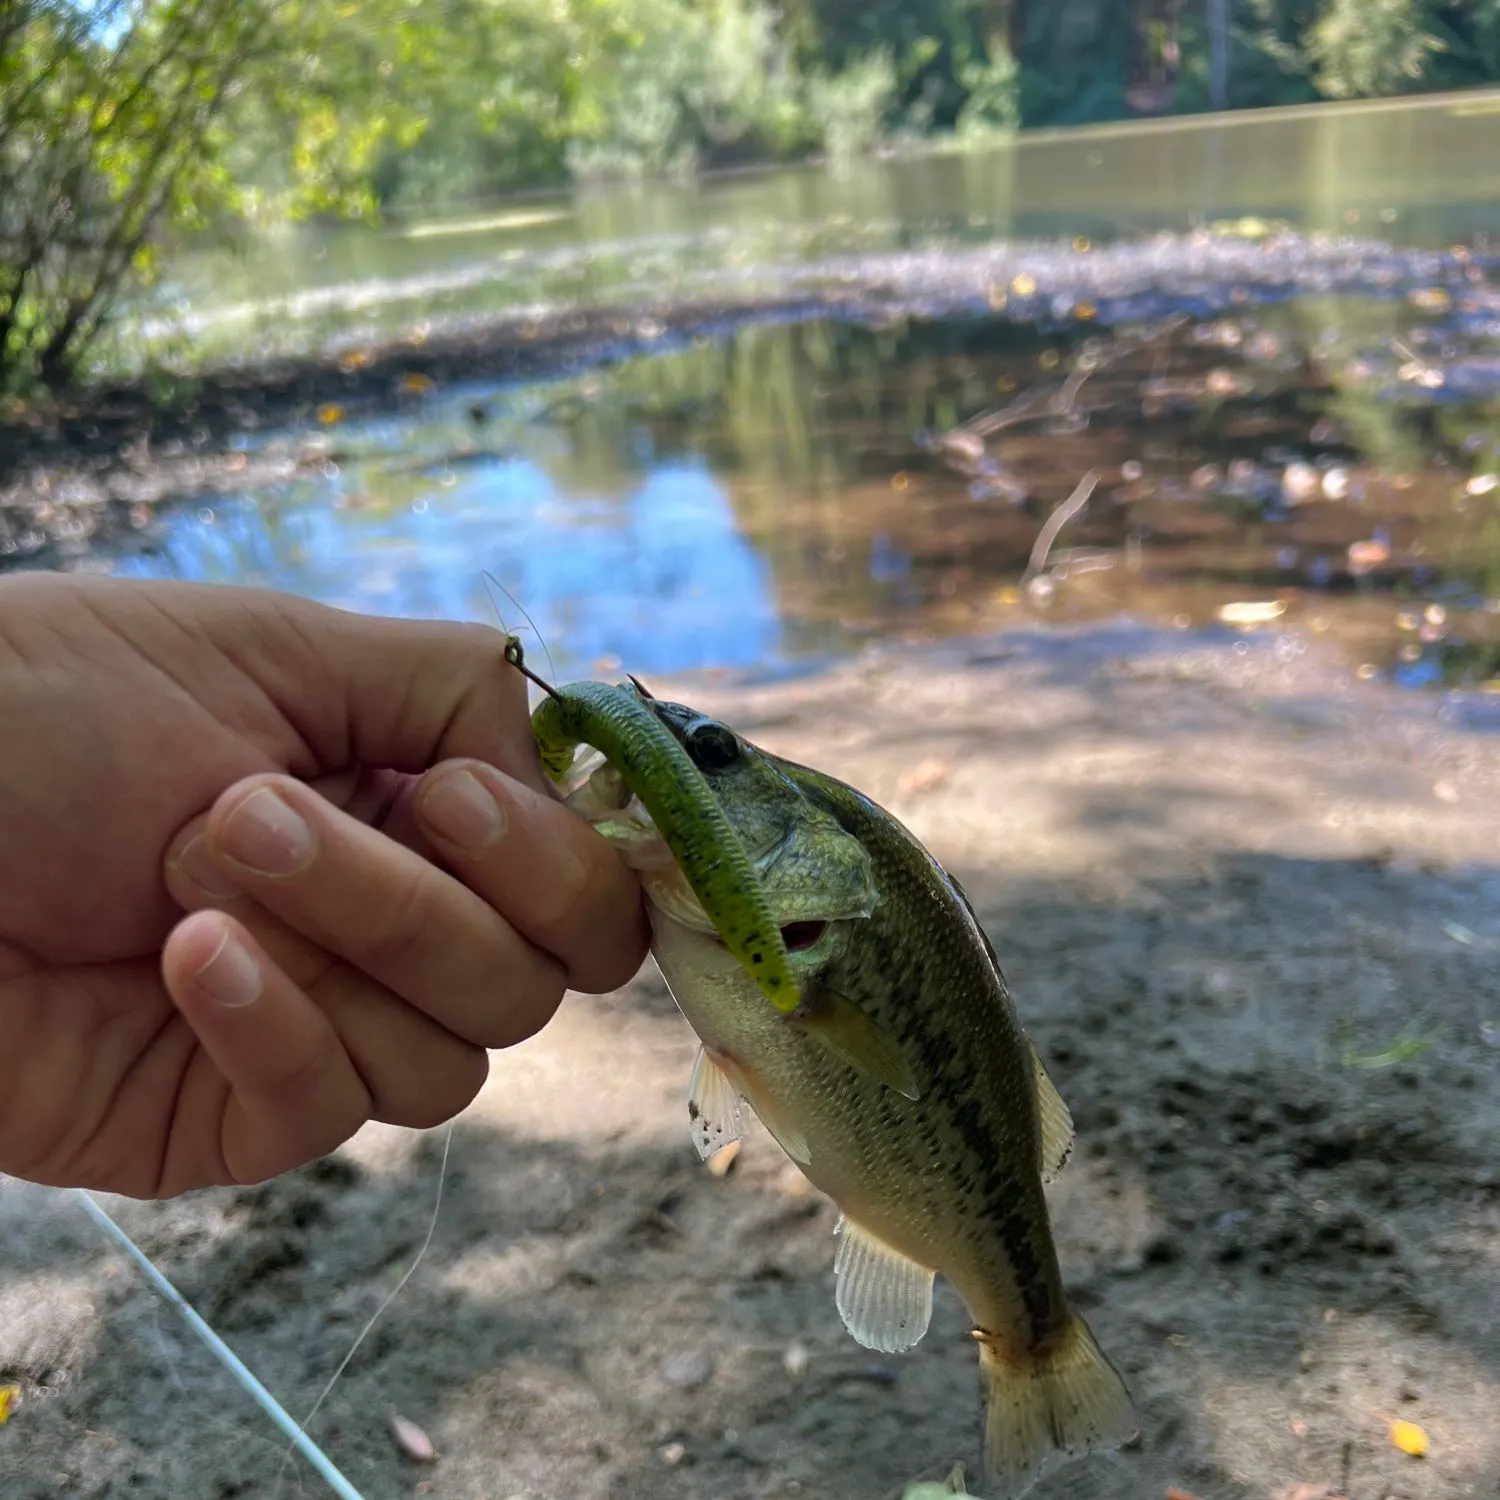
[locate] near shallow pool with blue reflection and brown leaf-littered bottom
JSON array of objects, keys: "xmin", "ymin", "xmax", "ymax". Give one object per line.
[{"xmin": 85, "ymin": 294, "xmax": 1500, "ymax": 702}]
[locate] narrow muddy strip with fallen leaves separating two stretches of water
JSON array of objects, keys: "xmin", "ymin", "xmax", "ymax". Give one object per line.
[{"xmin": 0, "ymin": 228, "xmax": 1500, "ymax": 486}]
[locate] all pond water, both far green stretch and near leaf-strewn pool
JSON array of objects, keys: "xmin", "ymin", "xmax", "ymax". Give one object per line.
[{"xmin": 41, "ymin": 95, "xmax": 1500, "ymax": 687}]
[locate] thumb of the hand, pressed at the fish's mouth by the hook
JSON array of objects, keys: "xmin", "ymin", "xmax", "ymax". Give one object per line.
[{"xmin": 218, "ymin": 588, "xmax": 548, "ymax": 791}]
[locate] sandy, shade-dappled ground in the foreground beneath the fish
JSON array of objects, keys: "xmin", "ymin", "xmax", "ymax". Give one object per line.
[{"xmin": 0, "ymin": 627, "xmax": 1500, "ymax": 1500}]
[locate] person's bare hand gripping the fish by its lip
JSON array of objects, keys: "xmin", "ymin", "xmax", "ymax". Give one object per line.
[{"xmin": 0, "ymin": 575, "xmax": 648, "ymax": 1197}]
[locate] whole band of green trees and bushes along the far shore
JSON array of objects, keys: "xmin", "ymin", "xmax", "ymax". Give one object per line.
[{"xmin": 0, "ymin": 0, "xmax": 1500, "ymax": 392}]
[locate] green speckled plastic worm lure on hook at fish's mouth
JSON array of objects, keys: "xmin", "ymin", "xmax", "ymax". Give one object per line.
[{"xmin": 506, "ymin": 636, "xmax": 801, "ymax": 1013}]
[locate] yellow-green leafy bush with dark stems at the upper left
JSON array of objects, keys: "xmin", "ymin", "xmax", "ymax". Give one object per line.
[{"xmin": 0, "ymin": 0, "xmax": 266, "ymax": 390}]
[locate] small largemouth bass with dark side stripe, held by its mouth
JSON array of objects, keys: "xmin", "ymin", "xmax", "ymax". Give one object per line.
[{"xmin": 546, "ymin": 680, "xmax": 1137, "ymax": 1500}]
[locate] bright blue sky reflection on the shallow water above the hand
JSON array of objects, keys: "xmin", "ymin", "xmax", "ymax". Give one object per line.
[{"xmin": 116, "ymin": 455, "xmax": 780, "ymax": 675}]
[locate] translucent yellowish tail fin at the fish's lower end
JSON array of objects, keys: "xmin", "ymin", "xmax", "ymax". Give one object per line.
[{"xmin": 975, "ymin": 1316, "xmax": 1136, "ymax": 1500}]
